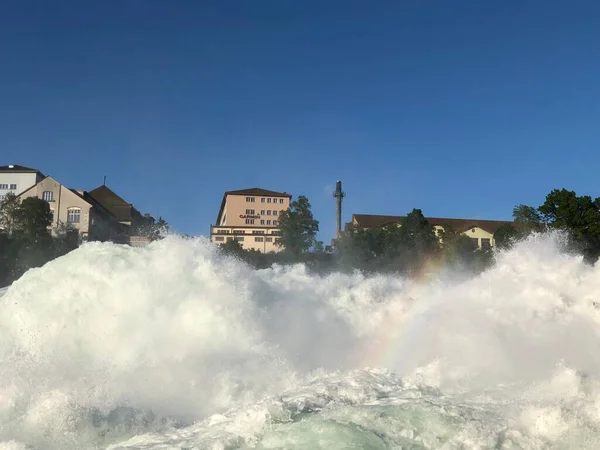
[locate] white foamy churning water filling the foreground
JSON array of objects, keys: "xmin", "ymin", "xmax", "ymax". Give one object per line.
[{"xmin": 0, "ymin": 235, "xmax": 600, "ymax": 450}]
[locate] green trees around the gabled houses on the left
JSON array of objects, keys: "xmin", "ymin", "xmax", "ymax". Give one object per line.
[{"xmin": 0, "ymin": 194, "xmax": 168, "ymax": 287}]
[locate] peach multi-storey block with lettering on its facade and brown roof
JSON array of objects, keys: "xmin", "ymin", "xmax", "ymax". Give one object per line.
[{"xmin": 210, "ymin": 188, "xmax": 292, "ymax": 253}]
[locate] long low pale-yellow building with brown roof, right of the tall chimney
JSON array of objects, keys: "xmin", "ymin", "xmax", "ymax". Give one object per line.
[{"xmin": 346, "ymin": 214, "xmax": 512, "ymax": 248}]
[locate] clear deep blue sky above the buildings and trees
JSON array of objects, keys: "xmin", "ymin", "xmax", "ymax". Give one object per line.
[{"xmin": 0, "ymin": 0, "xmax": 600, "ymax": 241}]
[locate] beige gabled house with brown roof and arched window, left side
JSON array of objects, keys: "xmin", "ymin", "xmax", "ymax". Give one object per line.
[{"xmin": 19, "ymin": 177, "xmax": 123, "ymax": 241}]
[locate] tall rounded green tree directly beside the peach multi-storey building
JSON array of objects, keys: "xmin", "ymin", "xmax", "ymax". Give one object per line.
[{"xmin": 277, "ymin": 195, "xmax": 319, "ymax": 258}]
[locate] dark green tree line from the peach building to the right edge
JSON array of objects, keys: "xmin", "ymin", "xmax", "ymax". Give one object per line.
[{"xmin": 220, "ymin": 189, "xmax": 600, "ymax": 276}]
